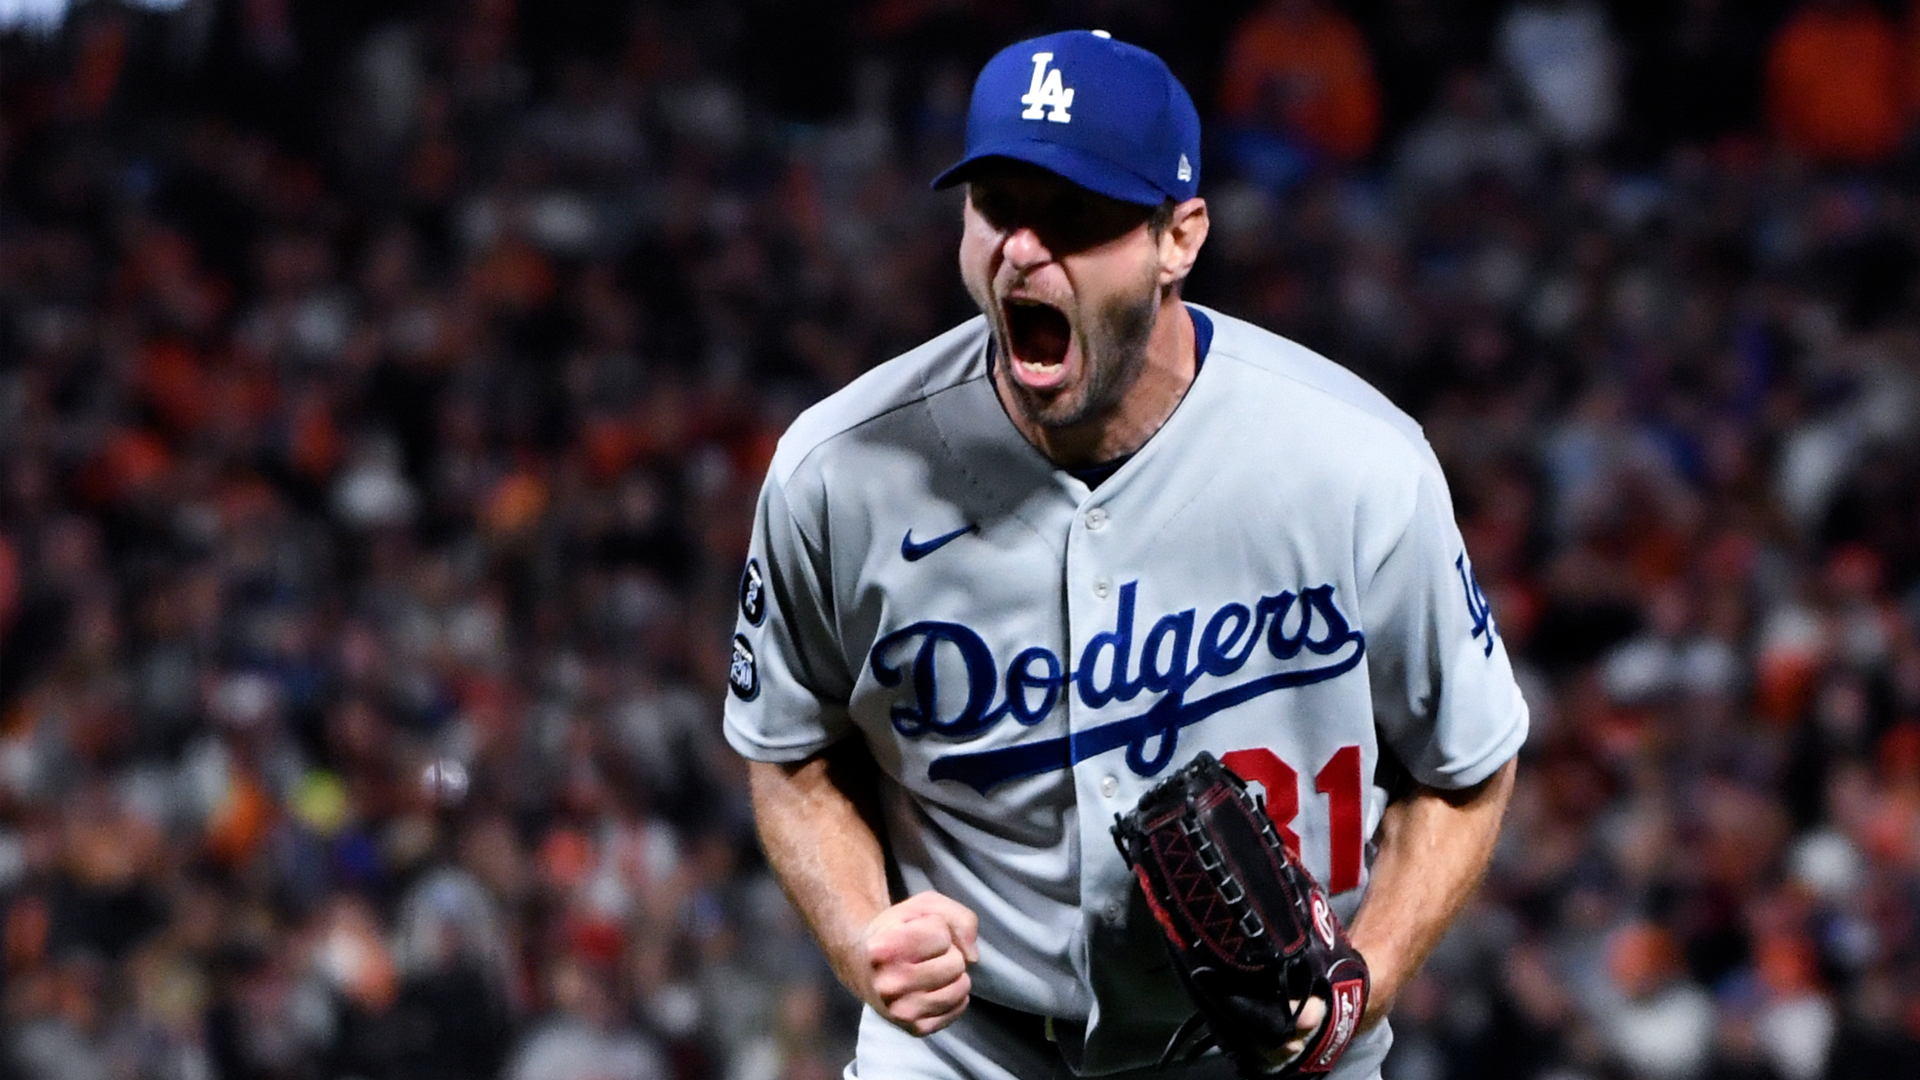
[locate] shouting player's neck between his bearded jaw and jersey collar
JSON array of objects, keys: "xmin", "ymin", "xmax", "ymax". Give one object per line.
[{"xmin": 1002, "ymin": 294, "xmax": 1198, "ymax": 469}]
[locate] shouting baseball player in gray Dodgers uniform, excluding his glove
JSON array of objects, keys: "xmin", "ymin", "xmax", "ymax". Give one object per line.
[{"xmin": 726, "ymin": 31, "xmax": 1526, "ymax": 1080}]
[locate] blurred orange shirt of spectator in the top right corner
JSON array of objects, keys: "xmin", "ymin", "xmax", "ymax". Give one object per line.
[{"xmin": 1766, "ymin": 0, "xmax": 1907, "ymax": 165}]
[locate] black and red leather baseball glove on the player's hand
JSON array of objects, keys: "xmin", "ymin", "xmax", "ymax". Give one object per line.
[{"xmin": 1114, "ymin": 753, "xmax": 1367, "ymax": 1080}]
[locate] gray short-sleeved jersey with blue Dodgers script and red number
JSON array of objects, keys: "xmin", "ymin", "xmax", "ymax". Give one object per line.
[{"xmin": 726, "ymin": 306, "xmax": 1526, "ymax": 1078}]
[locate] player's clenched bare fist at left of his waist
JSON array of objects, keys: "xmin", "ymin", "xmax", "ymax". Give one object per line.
[{"xmin": 854, "ymin": 892, "xmax": 979, "ymax": 1036}]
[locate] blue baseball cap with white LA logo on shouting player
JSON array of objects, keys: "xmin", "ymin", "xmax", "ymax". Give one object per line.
[{"xmin": 933, "ymin": 31, "xmax": 1200, "ymax": 206}]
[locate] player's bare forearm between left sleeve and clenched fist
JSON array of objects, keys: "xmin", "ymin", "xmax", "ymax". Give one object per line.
[{"xmin": 747, "ymin": 755, "xmax": 889, "ymax": 992}]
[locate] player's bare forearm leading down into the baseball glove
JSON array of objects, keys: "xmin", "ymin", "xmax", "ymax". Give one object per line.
[{"xmin": 1350, "ymin": 761, "xmax": 1515, "ymax": 1026}]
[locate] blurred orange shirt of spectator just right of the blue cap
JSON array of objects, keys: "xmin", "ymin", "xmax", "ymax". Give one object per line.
[{"xmin": 1221, "ymin": 0, "xmax": 1380, "ymax": 161}]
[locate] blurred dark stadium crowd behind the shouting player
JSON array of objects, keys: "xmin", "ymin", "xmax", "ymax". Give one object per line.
[{"xmin": 0, "ymin": 0, "xmax": 1920, "ymax": 1080}]
